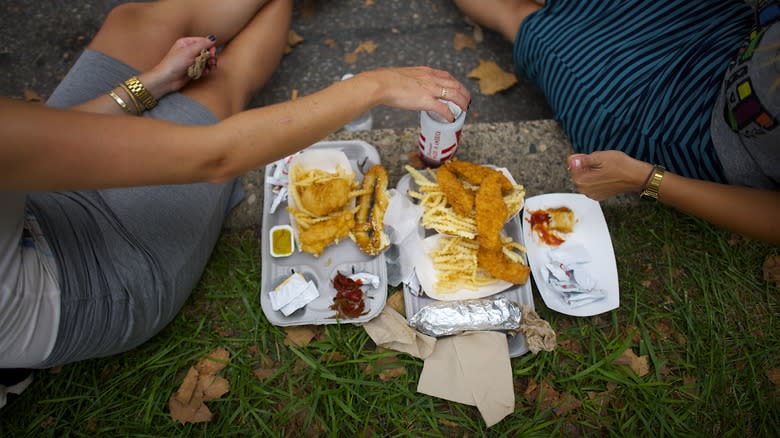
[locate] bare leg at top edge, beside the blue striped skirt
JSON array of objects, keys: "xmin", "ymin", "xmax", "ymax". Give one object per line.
[{"xmin": 455, "ymin": 0, "xmax": 541, "ymax": 43}]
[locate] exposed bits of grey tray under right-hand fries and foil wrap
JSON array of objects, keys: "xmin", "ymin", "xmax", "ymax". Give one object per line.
[{"xmin": 396, "ymin": 169, "xmax": 534, "ymax": 357}]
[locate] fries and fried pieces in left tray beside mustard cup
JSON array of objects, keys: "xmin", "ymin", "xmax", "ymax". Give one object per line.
[{"xmin": 287, "ymin": 165, "xmax": 357, "ymax": 257}]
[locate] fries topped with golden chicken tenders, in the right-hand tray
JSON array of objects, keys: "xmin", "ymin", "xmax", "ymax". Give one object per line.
[{"xmin": 406, "ymin": 161, "xmax": 530, "ymax": 293}]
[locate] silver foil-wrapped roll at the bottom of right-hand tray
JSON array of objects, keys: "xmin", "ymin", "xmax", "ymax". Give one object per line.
[{"xmin": 409, "ymin": 296, "xmax": 521, "ymax": 337}]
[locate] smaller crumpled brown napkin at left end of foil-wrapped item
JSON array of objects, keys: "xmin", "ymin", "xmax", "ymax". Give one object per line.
[{"xmin": 363, "ymin": 307, "xmax": 436, "ymax": 359}]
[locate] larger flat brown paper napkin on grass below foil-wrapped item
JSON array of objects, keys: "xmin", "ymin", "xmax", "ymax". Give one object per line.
[{"xmin": 417, "ymin": 331, "xmax": 515, "ymax": 427}]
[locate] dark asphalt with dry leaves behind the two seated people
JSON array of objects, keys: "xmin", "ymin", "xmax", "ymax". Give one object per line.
[{"xmin": 0, "ymin": 0, "xmax": 552, "ymax": 128}]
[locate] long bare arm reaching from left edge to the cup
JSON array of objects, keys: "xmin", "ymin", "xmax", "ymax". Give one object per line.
[{"xmin": 0, "ymin": 67, "xmax": 470, "ymax": 191}]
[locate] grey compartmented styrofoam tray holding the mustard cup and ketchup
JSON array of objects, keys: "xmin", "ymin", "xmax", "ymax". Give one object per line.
[{"xmin": 260, "ymin": 140, "xmax": 387, "ymax": 326}]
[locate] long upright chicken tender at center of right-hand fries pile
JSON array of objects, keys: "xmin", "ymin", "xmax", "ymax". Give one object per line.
[{"xmin": 475, "ymin": 172, "xmax": 509, "ymax": 251}]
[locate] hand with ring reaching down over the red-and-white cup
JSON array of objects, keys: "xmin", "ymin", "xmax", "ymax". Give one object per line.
[{"xmin": 358, "ymin": 67, "xmax": 471, "ymax": 122}]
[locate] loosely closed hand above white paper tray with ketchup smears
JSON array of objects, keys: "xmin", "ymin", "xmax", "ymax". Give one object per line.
[{"xmin": 567, "ymin": 151, "xmax": 653, "ymax": 201}]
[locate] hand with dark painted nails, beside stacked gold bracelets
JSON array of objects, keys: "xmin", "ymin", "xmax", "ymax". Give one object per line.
[{"xmin": 138, "ymin": 35, "xmax": 217, "ymax": 99}]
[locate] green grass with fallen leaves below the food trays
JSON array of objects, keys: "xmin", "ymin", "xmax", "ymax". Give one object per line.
[{"xmin": 0, "ymin": 206, "xmax": 780, "ymax": 437}]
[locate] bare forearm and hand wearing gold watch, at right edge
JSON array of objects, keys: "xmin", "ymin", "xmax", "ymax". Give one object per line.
[{"xmin": 568, "ymin": 151, "xmax": 780, "ymax": 244}]
